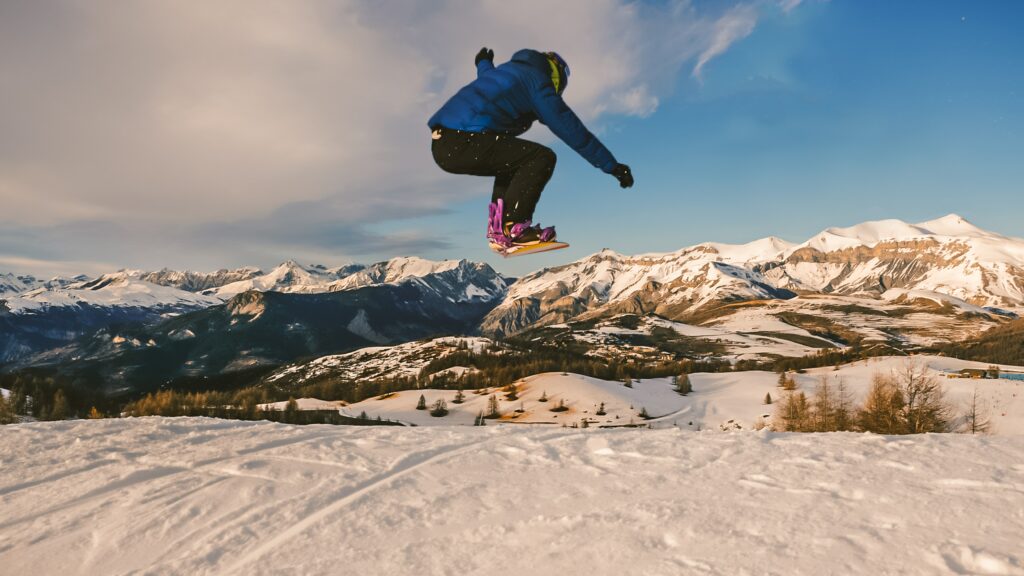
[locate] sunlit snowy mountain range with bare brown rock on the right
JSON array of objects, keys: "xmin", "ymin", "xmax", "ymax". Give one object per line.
[{"xmin": 482, "ymin": 214, "xmax": 1024, "ymax": 334}]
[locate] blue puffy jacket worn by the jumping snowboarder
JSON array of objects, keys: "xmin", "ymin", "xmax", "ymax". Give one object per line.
[{"xmin": 427, "ymin": 50, "xmax": 616, "ymax": 173}]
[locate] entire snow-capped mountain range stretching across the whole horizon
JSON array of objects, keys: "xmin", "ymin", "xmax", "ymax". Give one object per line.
[{"xmin": 0, "ymin": 214, "xmax": 1024, "ymax": 368}]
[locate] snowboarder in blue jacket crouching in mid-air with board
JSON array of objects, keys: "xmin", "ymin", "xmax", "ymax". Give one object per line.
[{"xmin": 428, "ymin": 47, "xmax": 633, "ymax": 253}]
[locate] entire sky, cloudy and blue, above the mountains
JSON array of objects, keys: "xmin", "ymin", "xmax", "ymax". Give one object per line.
[{"xmin": 0, "ymin": 0, "xmax": 1024, "ymax": 276}]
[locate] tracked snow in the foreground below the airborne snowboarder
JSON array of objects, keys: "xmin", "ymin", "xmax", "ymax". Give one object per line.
[{"xmin": 0, "ymin": 417, "xmax": 1024, "ymax": 576}]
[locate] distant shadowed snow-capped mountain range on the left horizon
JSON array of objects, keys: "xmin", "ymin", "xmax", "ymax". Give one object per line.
[{"xmin": 0, "ymin": 257, "xmax": 507, "ymax": 363}]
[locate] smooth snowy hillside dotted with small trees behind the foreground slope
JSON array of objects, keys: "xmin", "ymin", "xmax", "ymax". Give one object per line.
[{"xmin": 342, "ymin": 356, "xmax": 1024, "ymax": 436}]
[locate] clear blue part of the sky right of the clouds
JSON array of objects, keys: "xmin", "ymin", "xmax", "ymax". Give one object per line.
[{"xmin": 399, "ymin": 1, "xmax": 1024, "ymax": 274}]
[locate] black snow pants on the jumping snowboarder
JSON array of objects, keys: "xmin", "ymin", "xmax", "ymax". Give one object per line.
[{"xmin": 430, "ymin": 128, "xmax": 555, "ymax": 222}]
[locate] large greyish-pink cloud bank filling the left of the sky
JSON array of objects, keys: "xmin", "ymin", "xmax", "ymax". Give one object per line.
[{"xmin": 0, "ymin": 0, "xmax": 770, "ymax": 272}]
